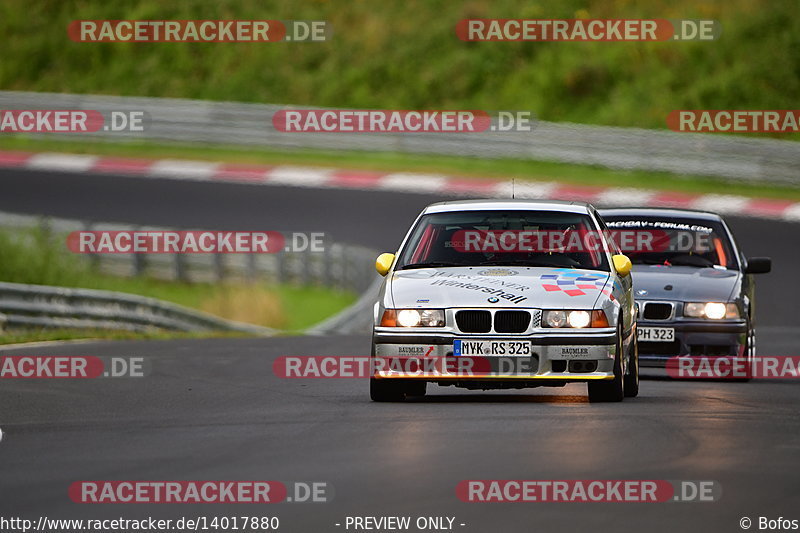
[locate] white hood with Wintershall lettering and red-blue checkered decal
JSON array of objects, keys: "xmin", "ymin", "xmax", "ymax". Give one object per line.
[{"xmin": 389, "ymin": 267, "xmax": 609, "ymax": 309}]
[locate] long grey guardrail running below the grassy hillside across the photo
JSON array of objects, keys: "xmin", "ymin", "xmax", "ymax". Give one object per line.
[{"xmin": 0, "ymin": 91, "xmax": 800, "ymax": 185}]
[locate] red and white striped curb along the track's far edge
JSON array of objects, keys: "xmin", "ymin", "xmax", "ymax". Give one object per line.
[{"xmin": 0, "ymin": 151, "xmax": 800, "ymax": 222}]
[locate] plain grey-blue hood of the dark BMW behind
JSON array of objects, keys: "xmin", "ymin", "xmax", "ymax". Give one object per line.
[{"xmin": 632, "ymin": 265, "xmax": 741, "ymax": 302}]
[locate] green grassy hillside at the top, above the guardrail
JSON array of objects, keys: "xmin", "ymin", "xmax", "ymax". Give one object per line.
[{"xmin": 0, "ymin": 0, "xmax": 800, "ymax": 139}]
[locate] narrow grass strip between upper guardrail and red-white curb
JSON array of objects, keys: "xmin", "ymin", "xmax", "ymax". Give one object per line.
[{"xmin": 6, "ymin": 137, "xmax": 800, "ymax": 200}]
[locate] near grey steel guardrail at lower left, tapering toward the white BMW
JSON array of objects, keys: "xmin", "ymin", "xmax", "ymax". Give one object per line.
[{"xmin": 0, "ymin": 282, "xmax": 276, "ymax": 336}]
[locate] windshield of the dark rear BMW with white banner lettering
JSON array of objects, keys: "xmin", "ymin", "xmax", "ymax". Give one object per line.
[{"xmin": 603, "ymin": 216, "xmax": 739, "ymax": 270}]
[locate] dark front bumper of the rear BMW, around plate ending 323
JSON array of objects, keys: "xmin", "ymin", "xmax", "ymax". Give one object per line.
[{"xmin": 638, "ymin": 319, "xmax": 747, "ymax": 367}]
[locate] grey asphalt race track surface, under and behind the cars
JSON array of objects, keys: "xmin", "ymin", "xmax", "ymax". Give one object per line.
[{"xmin": 0, "ymin": 170, "xmax": 800, "ymax": 532}]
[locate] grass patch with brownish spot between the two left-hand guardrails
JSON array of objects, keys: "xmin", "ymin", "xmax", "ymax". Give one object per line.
[{"xmin": 0, "ymin": 228, "xmax": 356, "ymax": 339}]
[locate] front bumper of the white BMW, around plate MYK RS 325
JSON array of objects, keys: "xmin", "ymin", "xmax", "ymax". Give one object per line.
[{"xmin": 373, "ymin": 328, "xmax": 617, "ymax": 384}]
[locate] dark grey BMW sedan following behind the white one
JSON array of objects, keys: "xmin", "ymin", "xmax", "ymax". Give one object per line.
[{"xmin": 600, "ymin": 208, "xmax": 772, "ymax": 367}]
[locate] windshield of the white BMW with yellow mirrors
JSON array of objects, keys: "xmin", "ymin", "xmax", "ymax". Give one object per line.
[{"xmin": 397, "ymin": 211, "xmax": 609, "ymax": 272}]
